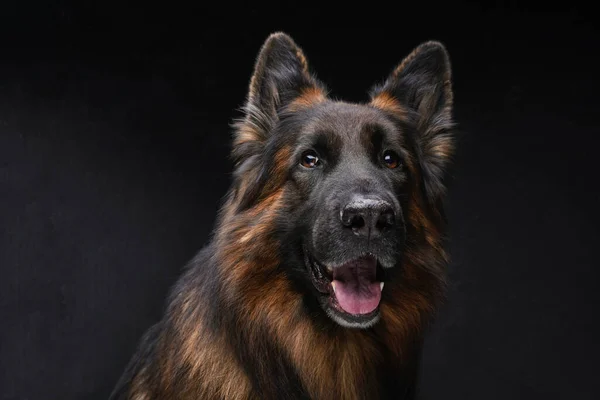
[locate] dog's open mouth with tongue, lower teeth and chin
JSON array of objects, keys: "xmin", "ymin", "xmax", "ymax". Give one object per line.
[{"xmin": 307, "ymin": 250, "xmax": 385, "ymax": 327}]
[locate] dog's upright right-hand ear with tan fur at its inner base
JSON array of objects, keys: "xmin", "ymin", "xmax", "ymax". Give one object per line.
[{"xmin": 371, "ymin": 41, "xmax": 454, "ymax": 200}]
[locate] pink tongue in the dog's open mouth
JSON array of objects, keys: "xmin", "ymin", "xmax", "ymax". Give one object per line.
[{"xmin": 332, "ymin": 279, "xmax": 381, "ymax": 314}]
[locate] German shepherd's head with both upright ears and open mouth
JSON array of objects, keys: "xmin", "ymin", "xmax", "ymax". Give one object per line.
[{"xmin": 233, "ymin": 33, "xmax": 453, "ymax": 328}]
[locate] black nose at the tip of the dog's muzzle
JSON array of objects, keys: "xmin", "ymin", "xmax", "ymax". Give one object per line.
[{"xmin": 340, "ymin": 198, "xmax": 396, "ymax": 238}]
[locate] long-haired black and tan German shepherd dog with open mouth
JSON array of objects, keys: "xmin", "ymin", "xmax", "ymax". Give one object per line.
[{"xmin": 111, "ymin": 33, "xmax": 454, "ymax": 400}]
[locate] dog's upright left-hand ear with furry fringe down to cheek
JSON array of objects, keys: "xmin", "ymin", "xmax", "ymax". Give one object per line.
[{"xmin": 232, "ymin": 32, "xmax": 326, "ymax": 209}]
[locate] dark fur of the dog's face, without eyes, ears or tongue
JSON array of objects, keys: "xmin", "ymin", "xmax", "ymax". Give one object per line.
[{"xmin": 277, "ymin": 102, "xmax": 409, "ymax": 327}]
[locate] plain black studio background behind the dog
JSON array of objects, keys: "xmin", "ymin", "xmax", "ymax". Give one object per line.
[{"xmin": 0, "ymin": 0, "xmax": 600, "ymax": 399}]
